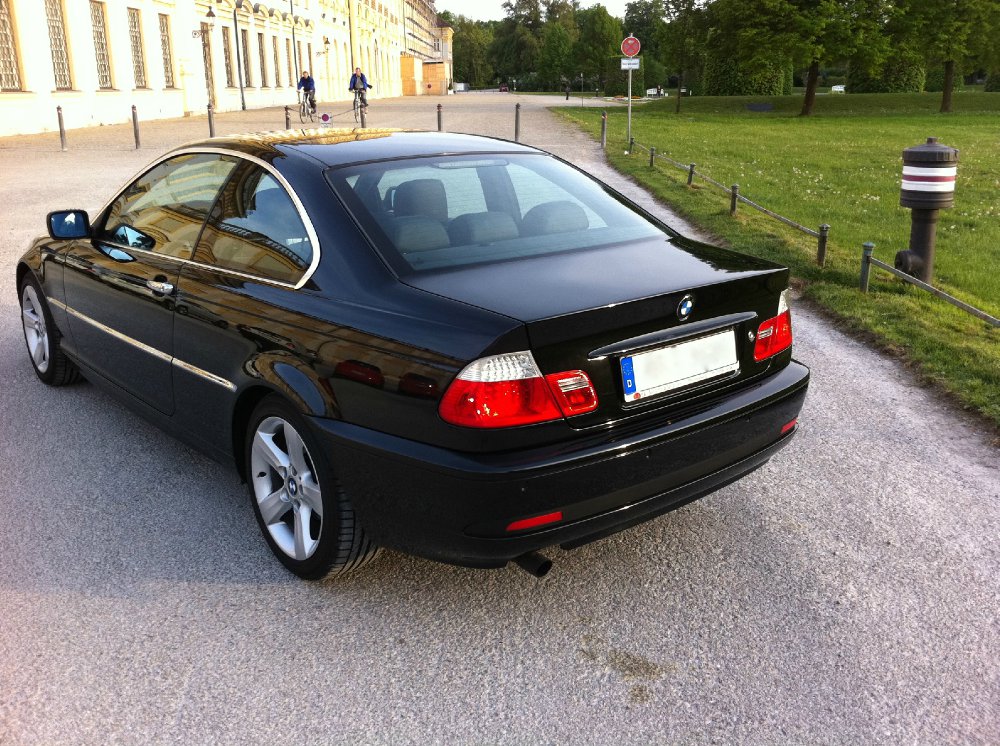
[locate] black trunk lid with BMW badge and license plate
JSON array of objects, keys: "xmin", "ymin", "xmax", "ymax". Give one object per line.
[{"xmin": 403, "ymin": 238, "xmax": 789, "ymax": 429}]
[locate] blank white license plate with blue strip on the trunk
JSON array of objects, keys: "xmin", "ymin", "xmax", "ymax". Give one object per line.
[{"xmin": 621, "ymin": 329, "xmax": 740, "ymax": 401}]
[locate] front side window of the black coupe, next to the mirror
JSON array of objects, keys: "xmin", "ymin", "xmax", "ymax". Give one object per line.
[{"xmin": 95, "ymin": 153, "xmax": 236, "ymax": 259}]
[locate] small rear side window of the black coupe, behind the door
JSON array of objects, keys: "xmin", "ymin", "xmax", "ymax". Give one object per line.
[{"xmin": 195, "ymin": 164, "xmax": 313, "ymax": 284}]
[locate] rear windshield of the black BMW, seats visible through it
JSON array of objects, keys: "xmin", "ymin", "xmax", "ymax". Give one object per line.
[{"xmin": 327, "ymin": 154, "xmax": 664, "ymax": 274}]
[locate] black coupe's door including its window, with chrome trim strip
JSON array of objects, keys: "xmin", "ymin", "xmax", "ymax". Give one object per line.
[{"xmin": 65, "ymin": 153, "xmax": 235, "ymax": 415}]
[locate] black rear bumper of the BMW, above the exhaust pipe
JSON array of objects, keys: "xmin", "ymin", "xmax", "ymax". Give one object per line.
[{"xmin": 313, "ymin": 362, "xmax": 809, "ymax": 567}]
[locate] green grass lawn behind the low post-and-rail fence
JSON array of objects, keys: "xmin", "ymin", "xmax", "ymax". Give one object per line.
[{"xmin": 560, "ymin": 91, "xmax": 1000, "ymax": 429}]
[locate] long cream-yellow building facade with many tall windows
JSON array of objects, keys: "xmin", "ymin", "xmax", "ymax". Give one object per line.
[{"xmin": 0, "ymin": 0, "xmax": 452, "ymax": 135}]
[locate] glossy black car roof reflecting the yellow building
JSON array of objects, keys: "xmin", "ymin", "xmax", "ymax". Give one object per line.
[{"xmin": 179, "ymin": 128, "xmax": 540, "ymax": 166}]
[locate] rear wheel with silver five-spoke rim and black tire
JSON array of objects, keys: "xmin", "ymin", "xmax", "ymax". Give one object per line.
[{"xmin": 244, "ymin": 395, "xmax": 379, "ymax": 580}]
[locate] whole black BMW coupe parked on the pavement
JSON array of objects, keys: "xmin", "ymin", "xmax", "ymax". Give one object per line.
[{"xmin": 17, "ymin": 130, "xmax": 809, "ymax": 578}]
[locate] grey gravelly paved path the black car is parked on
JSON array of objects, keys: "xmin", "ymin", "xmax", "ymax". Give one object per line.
[{"xmin": 0, "ymin": 94, "xmax": 1000, "ymax": 746}]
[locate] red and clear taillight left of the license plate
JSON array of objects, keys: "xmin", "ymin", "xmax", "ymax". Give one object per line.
[{"xmin": 438, "ymin": 351, "xmax": 597, "ymax": 428}]
